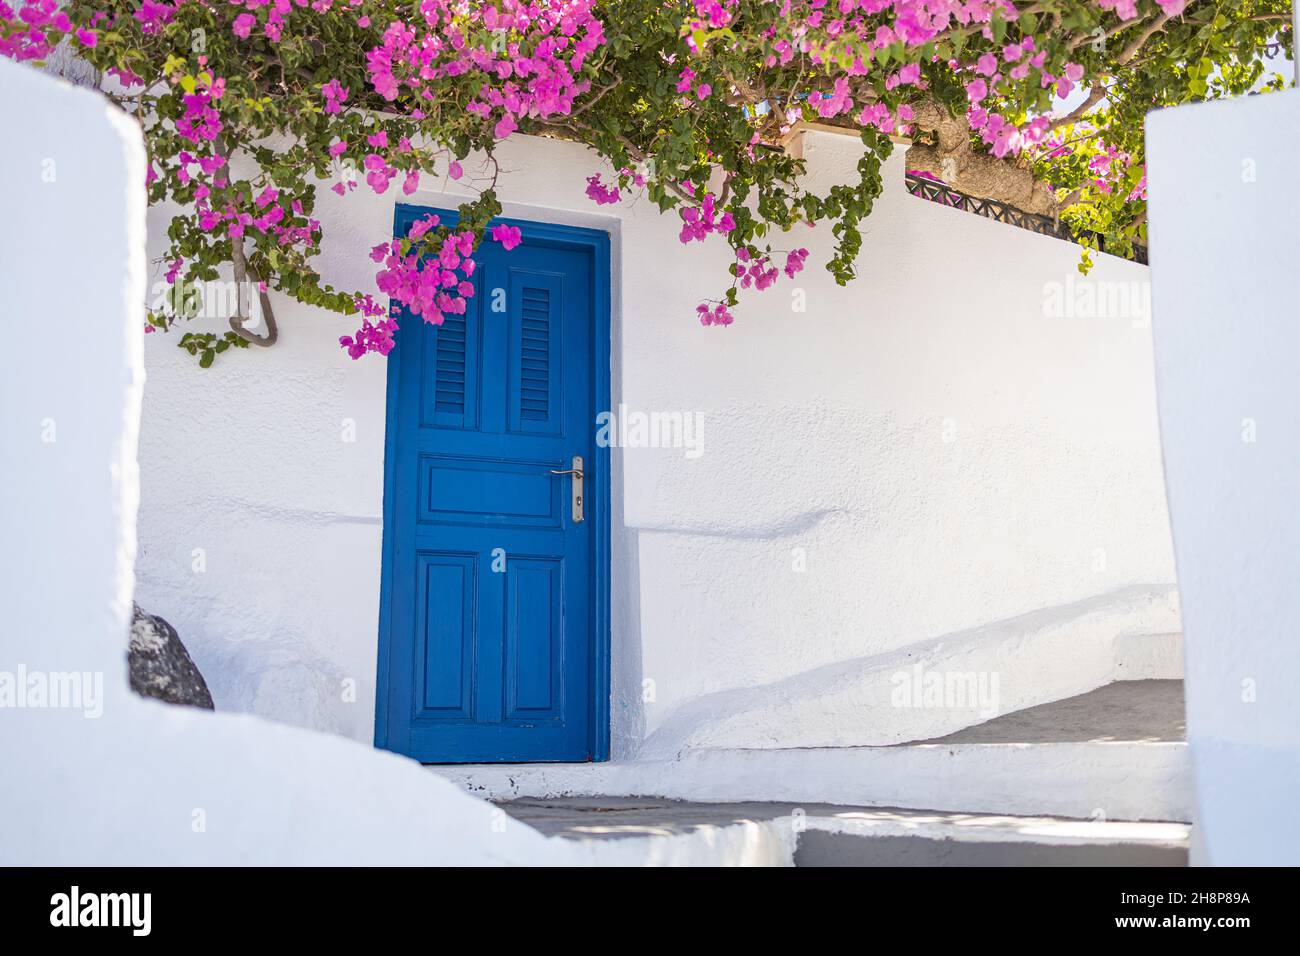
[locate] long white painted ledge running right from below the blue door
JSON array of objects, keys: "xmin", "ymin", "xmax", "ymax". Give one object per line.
[{"xmin": 441, "ymin": 741, "xmax": 1192, "ymax": 822}]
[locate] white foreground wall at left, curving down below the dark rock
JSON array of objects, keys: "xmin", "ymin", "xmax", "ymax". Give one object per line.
[{"xmin": 0, "ymin": 59, "xmax": 624, "ymax": 865}]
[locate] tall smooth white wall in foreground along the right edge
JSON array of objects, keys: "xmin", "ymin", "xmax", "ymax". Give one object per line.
[{"xmin": 1147, "ymin": 90, "xmax": 1300, "ymax": 866}]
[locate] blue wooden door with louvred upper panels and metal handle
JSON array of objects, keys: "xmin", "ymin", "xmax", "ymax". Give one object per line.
[{"xmin": 376, "ymin": 206, "xmax": 610, "ymax": 763}]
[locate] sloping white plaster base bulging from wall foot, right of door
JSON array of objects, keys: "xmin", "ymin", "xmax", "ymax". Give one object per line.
[{"xmin": 640, "ymin": 584, "xmax": 1182, "ymax": 758}]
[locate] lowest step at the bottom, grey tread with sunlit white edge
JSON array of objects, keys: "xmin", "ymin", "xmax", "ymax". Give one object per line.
[{"xmin": 501, "ymin": 797, "xmax": 1190, "ymax": 866}]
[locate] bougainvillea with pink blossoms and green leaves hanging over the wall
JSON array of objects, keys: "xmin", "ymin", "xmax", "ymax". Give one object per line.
[{"xmin": 0, "ymin": 0, "xmax": 1291, "ymax": 364}]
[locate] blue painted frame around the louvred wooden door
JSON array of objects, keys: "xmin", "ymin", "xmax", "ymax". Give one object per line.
[{"xmin": 374, "ymin": 203, "xmax": 612, "ymax": 761}]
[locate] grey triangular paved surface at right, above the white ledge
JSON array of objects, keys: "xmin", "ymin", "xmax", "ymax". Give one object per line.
[{"xmin": 924, "ymin": 680, "xmax": 1187, "ymax": 744}]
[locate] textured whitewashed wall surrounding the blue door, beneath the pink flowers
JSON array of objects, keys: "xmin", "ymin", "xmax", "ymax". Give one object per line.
[{"xmin": 138, "ymin": 128, "xmax": 1174, "ymax": 756}]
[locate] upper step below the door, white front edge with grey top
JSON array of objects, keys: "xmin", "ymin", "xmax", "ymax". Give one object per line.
[{"xmin": 433, "ymin": 680, "xmax": 1192, "ymax": 822}]
